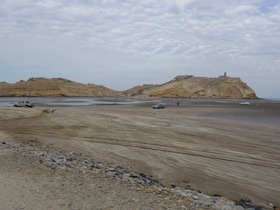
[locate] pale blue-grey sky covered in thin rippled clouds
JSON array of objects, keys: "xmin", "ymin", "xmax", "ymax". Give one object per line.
[{"xmin": 0, "ymin": 0, "xmax": 280, "ymax": 98}]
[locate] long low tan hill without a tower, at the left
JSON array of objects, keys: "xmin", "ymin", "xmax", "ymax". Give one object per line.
[{"xmin": 0, "ymin": 78, "xmax": 120, "ymax": 96}]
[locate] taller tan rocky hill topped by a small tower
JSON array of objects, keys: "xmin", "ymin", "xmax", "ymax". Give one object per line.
[{"xmin": 124, "ymin": 75, "xmax": 257, "ymax": 99}]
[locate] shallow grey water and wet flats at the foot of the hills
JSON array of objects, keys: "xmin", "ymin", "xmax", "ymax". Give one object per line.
[{"xmin": 0, "ymin": 97, "xmax": 280, "ymax": 126}]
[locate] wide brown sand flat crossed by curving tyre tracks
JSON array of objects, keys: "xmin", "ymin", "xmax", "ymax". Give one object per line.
[{"xmin": 0, "ymin": 101, "xmax": 280, "ymax": 205}]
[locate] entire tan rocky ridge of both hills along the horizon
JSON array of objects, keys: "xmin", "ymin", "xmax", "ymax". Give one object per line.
[{"xmin": 0, "ymin": 75, "xmax": 257, "ymax": 99}]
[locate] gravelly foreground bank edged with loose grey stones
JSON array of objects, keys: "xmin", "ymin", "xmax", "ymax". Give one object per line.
[{"xmin": 0, "ymin": 140, "xmax": 280, "ymax": 210}]
